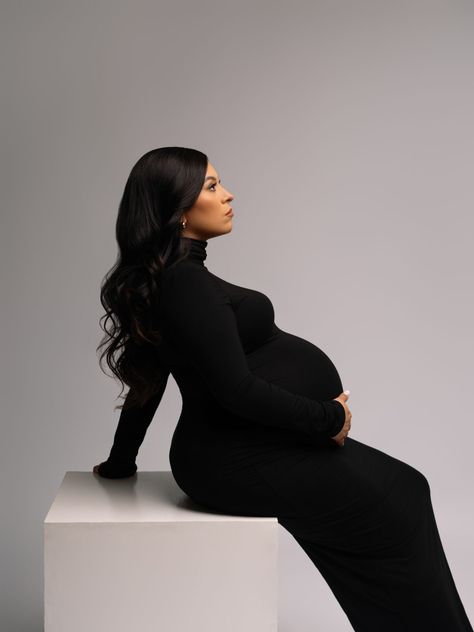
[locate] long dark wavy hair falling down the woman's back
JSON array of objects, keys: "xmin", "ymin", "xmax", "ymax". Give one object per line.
[{"xmin": 96, "ymin": 147, "xmax": 208, "ymax": 409}]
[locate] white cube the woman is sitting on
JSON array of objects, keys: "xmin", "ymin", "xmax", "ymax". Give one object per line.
[{"xmin": 44, "ymin": 471, "xmax": 278, "ymax": 632}]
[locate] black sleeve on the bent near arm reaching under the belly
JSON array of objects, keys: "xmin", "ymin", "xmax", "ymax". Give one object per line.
[{"xmin": 162, "ymin": 262, "xmax": 345, "ymax": 438}]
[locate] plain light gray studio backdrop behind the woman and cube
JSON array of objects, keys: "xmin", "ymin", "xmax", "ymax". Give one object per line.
[{"xmin": 0, "ymin": 0, "xmax": 474, "ymax": 632}]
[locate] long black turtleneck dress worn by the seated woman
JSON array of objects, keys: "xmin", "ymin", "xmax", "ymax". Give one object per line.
[{"xmin": 99, "ymin": 237, "xmax": 473, "ymax": 632}]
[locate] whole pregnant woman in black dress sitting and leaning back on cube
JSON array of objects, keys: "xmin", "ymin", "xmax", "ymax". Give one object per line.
[{"xmin": 94, "ymin": 147, "xmax": 472, "ymax": 632}]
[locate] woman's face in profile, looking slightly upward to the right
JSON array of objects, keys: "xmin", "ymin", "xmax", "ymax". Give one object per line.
[{"xmin": 181, "ymin": 162, "xmax": 234, "ymax": 239}]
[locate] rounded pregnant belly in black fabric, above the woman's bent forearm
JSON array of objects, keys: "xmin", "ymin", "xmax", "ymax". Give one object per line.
[{"xmin": 247, "ymin": 329, "xmax": 344, "ymax": 400}]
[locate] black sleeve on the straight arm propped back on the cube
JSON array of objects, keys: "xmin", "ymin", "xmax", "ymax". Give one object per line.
[{"xmin": 99, "ymin": 370, "xmax": 169, "ymax": 478}]
